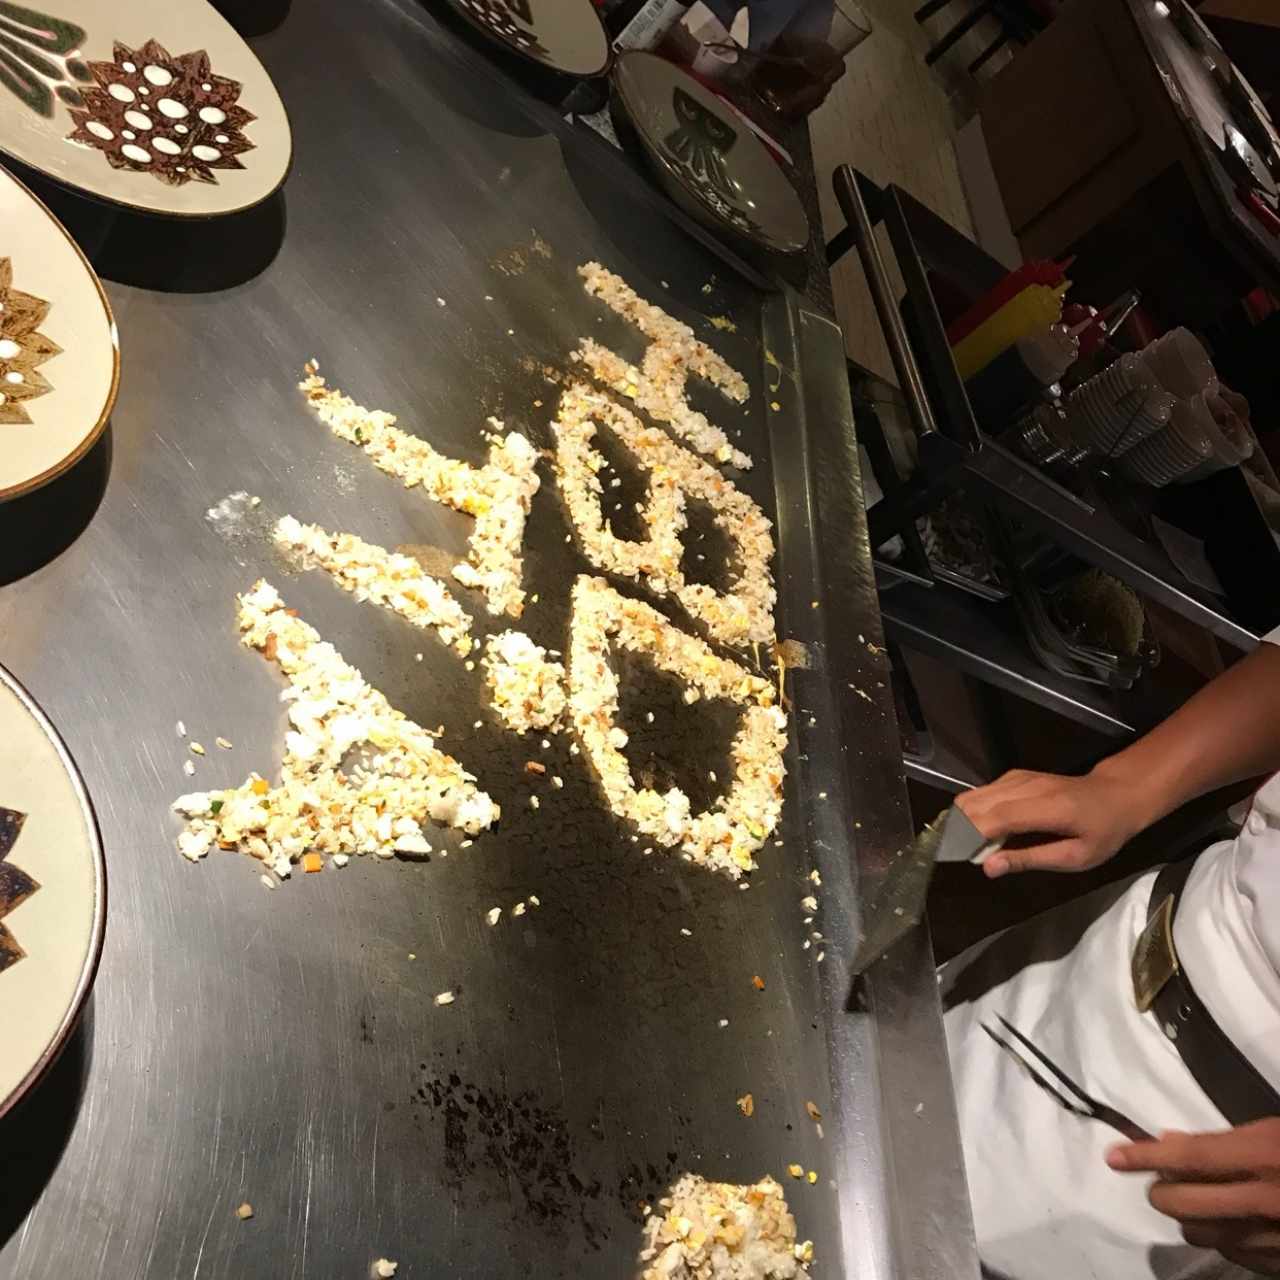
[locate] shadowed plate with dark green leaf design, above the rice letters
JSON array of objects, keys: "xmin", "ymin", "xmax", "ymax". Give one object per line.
[{"xmin": 613, "ymin": 52, "xmax": 809, "ymax": 253}]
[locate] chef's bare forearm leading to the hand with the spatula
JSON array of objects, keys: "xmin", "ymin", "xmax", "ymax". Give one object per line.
[{"xmin": 1096, "ymin": 644, "xmax": 1280, "ymax": 826}]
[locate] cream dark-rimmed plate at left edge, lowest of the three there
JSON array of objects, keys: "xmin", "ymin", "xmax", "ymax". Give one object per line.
[{"xmin": 0, "ymin": 667, "xmax": 106, "ymax": 1116}]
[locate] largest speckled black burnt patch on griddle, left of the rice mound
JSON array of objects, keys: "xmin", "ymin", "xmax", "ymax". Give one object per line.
[{"xmin": 412, "ymin": 1064, "xmax": 609, "ymax": 1249}]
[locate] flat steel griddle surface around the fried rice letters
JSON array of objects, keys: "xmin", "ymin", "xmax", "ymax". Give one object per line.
[{"xmin": 0, "ymin": 0, "xmax": 963, "ymax": 1280}]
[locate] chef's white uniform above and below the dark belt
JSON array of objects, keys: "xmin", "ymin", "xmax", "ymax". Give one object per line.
[{"xmin": 942, "ymin": 631, "xmax": 1280, "ymax": 1280}]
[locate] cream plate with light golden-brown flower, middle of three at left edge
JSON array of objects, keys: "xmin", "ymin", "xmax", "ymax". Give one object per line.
[{"xmin": 0, "ymin": 168, "xmax": 120, "ymax": 504}]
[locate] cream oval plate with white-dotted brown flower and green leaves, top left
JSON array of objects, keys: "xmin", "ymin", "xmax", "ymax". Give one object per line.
[{"xmin": 0, "ymin": 0, "xmax": 293, "ymax": 218}]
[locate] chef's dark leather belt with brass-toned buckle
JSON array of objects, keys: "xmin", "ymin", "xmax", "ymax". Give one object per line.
[{"xmin": 1134, "ymin": 858, "xmax": 1280, "ymax": 1125}]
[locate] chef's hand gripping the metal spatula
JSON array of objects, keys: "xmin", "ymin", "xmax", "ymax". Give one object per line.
[{"xmin": 955, "ymin": 765, "xmax": 1149, "ymax": 878}]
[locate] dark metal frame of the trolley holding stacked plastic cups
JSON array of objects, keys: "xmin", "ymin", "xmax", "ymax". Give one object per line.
[{"xmin": 828, "ymin": 166, "xmax": 1257, "ymax": 790}]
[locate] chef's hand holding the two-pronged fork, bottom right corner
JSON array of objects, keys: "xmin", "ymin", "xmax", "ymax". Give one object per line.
[{"xmin": 1107, "ymin": 1116, "xmax": 1280, "ymax": 1276}]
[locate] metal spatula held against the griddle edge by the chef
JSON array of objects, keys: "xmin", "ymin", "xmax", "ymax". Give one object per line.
[{"xmin": 852, "ymin": 806, "xmax": 1001, "ymax": 977}]
